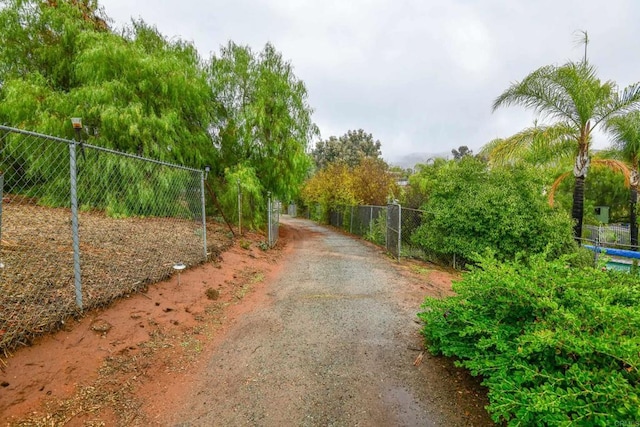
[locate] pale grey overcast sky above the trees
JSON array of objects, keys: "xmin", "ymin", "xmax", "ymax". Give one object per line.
[{"xmin": 100, "ymin": 0, "xmax": 640, "ymax": 166}]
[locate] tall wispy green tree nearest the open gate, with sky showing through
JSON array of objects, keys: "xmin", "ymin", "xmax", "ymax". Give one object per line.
[{"xmin": 209, "ymin": 42, "xmax": 318, "ymax": 200}]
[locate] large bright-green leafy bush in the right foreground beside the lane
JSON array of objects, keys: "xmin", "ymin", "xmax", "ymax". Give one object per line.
[{"xmin": 419, "ymin": 256, "xmax": 640, "ymax": 426}]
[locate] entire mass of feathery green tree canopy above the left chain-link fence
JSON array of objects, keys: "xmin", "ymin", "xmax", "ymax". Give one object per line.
[{"xmin": 0, "ymin": 0, "xmax": 318, "ymax": 227}]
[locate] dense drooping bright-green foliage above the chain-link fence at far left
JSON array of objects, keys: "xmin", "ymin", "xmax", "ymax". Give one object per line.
[{"xmin": 0, "ymin": 0, "xmax": 213, "ymax": 166}]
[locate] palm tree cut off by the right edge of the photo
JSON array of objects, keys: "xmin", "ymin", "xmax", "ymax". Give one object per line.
[{"xmin": 605, "ymin": 111, "xmax": 640, "ymax": 250}]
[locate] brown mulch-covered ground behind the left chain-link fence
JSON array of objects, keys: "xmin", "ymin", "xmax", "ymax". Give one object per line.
[{"xmin": 0, "ymin": 202, "xmax": 232, "ymax": 356}]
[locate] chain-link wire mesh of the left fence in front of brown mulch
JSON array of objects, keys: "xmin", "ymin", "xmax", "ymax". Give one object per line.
[{"xmin": 0, "ymin": 126, "xmax": 212, "ymax": 350}]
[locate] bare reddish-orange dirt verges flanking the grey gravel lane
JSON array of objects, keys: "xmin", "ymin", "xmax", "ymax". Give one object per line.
[{"xmin": 0, "ymin": 226, "xmax": 455, "ymax": 426}]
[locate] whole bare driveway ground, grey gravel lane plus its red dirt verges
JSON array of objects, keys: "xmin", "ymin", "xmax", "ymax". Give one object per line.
[{"xmin": 0, "ymin": 219, "xmax": 491, "ymax": 426}]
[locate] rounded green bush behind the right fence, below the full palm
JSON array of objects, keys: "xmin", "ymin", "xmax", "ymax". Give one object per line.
[{"xmin": 412, "ymin": 157, "xmax": 575, "ymax": 261}]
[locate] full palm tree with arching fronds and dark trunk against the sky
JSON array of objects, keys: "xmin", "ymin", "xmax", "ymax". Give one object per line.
[{"xmin": 493, "ymin": 60, "xmax": 640, "ymax": 242}]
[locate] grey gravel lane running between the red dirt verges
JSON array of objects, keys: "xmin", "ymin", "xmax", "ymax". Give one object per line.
[{"xmin": 172, "ymin": 218, "xmax": 493, "ymax": 426}]
